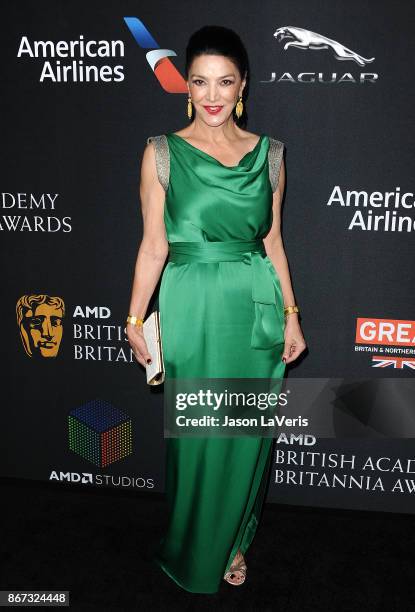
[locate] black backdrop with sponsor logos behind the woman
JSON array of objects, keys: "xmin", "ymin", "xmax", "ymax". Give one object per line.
[{"xmin": 0, "ymin": 0, "xmax": 415, "ymax": 513}]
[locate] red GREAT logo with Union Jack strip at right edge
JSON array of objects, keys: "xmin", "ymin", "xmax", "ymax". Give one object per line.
[{"xmin": 355, "ymin": 317, "xmax": 415, "ymax": 370}]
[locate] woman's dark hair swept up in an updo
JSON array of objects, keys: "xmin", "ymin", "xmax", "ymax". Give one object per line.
[{"xmin": 185, "ymin": 25, "xmax": 249, "ymax": 128}]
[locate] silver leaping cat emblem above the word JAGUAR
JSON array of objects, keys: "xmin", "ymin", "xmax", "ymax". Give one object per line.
[{"xmin": 274, "ymin": 26, "xmax": 375, "ymax": 66}]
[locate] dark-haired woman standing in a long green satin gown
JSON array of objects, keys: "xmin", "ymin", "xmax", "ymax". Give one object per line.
[{"xmin": 128, "ymin": 26, "xmax": 305, "ymax": 593}]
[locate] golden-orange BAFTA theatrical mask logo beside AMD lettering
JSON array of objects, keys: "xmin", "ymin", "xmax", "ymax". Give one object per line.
[{"xmin": 16, "ymin": 294, "xmax": 65, "ymax": 357}]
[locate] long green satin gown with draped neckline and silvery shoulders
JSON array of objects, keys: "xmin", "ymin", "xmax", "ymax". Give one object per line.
[{"xmin": 147, "ymin": 133, "xmax": 285, "ymax": 593}]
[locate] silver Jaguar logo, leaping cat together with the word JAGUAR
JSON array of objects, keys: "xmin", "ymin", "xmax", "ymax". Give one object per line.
[{"xmin": 261, "ymin": 26, "xmax": 379, "ymax": 85}]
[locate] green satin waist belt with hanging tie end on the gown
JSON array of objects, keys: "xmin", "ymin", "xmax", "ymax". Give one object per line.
[{"xmin": 169, "ymin": 238, "xmax": 285, "ymax": 349}]
